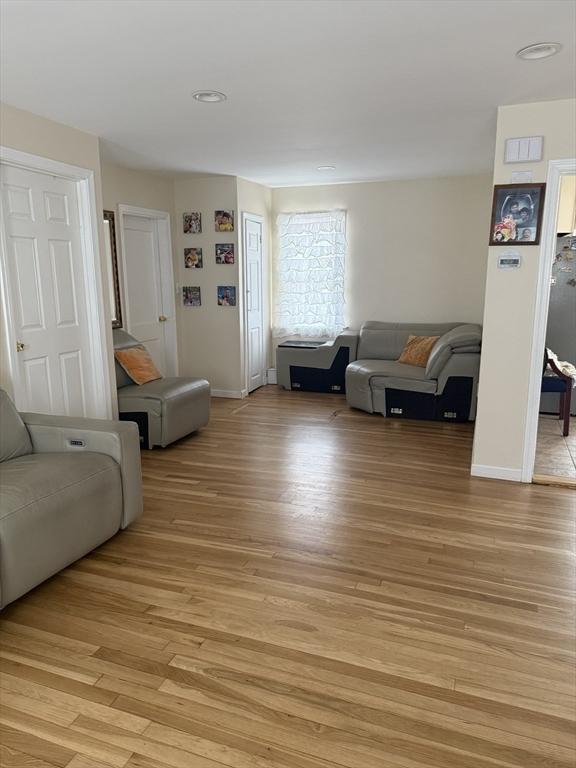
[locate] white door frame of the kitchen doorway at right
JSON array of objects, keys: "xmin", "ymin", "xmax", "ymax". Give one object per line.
[{"xmin": 520, "ymin": 158, "xmax": 576, "ymax": 483}]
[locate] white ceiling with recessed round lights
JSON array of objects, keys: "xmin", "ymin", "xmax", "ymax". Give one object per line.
[{"xmin": 0, "ymin": 0, "xmax": 576, "ymax": 186}]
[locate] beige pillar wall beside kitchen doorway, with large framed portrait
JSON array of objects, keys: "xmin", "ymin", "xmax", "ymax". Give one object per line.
[{"xmin": 473, "ymin": 99, "xmax": 576, "ymax": 478}]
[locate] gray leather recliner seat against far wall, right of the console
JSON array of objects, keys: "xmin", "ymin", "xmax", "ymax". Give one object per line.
[{"xmin": 346, "ymin": 321, "xmax": 482, "ymax": 421}]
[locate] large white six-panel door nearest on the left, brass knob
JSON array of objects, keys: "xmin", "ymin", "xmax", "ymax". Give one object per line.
[{"xmin": 1, "ymin": 165, "xmax": 95, "ymax": 416}]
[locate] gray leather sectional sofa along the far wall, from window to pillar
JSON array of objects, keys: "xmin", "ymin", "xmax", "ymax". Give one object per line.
[{"xmin": 276, "ymin": 320, "xmax": 482, "ymax": 421}]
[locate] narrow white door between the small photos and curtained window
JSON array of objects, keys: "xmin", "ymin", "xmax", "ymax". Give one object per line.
[{"xmin": 244, "ymin": 215, "xmax": 266, "ymax": 392}]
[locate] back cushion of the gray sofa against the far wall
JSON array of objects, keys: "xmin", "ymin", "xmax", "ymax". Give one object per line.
[{"xmin": 357, "ymin": 320, "xmax": 460, "ymax": 360}]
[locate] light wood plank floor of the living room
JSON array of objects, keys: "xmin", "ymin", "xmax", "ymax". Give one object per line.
[{"xmin": 0, "ymin": 387, "xmax": 576, "ymax": 768}]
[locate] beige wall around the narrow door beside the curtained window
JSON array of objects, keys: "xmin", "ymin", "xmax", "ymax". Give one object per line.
[{"xmin": 238, "ymin": 178, "xmax": 273, "ymax": 375}]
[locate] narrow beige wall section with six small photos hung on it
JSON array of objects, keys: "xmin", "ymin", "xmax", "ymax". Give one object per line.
[{"xmin": 174, "ymin": 176, "xmax": 244, "ymax": 395}]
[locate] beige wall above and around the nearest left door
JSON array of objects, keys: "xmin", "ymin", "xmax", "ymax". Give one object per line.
[{"xmin": 0, "ymin": 104, "xmax": 116, "ymax": 408}]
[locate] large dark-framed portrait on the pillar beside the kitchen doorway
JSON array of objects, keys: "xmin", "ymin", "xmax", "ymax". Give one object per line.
[{"xmin": 489, "ymin": 184, "xmax": 546, "ymax": 246}]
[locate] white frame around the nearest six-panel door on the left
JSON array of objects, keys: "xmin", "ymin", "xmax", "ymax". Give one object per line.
[{"xmin": 0, "ymin": 146, "xmax": 117, "ymax": 419}]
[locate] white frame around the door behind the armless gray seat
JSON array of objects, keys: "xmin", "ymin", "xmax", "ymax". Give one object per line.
[{"xmin": 118, "ymin": 203, "xmax": 178, "ymax": 376}]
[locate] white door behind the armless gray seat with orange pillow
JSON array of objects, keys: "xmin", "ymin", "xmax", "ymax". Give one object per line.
[{"xmin": 122, "ymin": 215, "xmax": 168, "ymax": 375}]
